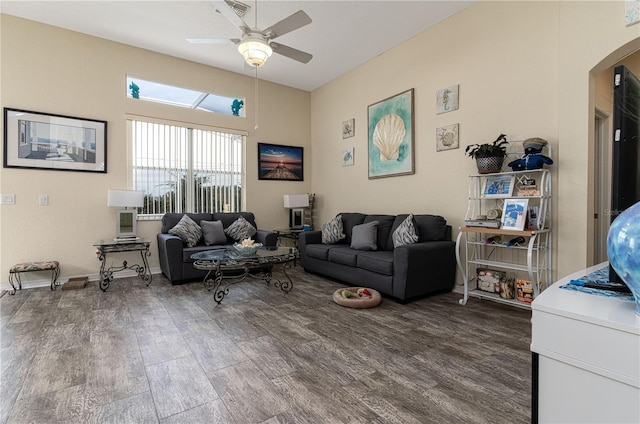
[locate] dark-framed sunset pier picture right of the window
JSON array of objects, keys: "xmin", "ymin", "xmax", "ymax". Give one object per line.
[{"xmin": 258, "ymin": 143, "xmax": 304, "ymax": 181}]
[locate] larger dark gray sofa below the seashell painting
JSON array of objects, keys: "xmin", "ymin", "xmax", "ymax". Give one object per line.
[{"xmin": 299, "ymin": 213, "xmax": 456, "ymax": 302}]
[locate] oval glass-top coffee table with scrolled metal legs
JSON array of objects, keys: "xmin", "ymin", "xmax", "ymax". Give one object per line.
[{"xmin": 191, "ymin": 247, "xmax": 298, "ymax": 304}]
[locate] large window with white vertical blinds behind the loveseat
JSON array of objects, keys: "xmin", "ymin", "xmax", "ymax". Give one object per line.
[{"xmin": 129, "ymin": 120, "xmax": 244, "ymax": 219}]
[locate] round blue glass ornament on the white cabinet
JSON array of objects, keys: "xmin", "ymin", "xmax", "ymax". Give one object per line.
[{"xmin": 607, "ymin": 202, "xmax": 640, "ymax": 315}]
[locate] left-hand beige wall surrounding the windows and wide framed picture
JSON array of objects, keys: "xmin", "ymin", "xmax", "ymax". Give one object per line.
[{"xmin": 0, "ymin": 15, "xmax": 311, "ymax": 283}]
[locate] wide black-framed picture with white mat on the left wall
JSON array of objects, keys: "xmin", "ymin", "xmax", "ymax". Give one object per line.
[{"xmin": 3, "ymin": 108, "xmax": 107, "ymax": 173}]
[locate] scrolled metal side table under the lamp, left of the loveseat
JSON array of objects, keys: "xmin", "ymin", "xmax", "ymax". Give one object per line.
[{"xmin": 93, "ymin": 239, "xmax": 151, "ymax": 291}]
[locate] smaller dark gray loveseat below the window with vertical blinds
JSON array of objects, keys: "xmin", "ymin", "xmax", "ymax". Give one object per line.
[{"xmin": 157, "ymin": 212, "xmax": 278, "ymax": 284}]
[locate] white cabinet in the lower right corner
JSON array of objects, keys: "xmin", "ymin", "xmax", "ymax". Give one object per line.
[{"xmin": 531, "ymin": 263, "xmax": 640, "ymax": 423}]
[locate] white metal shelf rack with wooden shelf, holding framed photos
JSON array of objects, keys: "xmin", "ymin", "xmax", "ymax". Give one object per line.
[{"xmin": 456, "ymin": 169, "xmax": 553, "ymax": 308}]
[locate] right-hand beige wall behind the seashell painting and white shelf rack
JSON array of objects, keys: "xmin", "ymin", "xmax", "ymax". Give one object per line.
[{"xmin": 311, "ymin": 1, "xmax": 640, "ymax": 284}]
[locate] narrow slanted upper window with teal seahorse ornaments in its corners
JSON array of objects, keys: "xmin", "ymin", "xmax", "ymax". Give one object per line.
[{"xmin": 126, "ymin": 75, "xmax": 244, "ymax": 117}]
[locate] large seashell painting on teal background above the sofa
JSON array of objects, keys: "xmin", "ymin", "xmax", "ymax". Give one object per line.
[{"xmin": 368, "ymin": 89, "xmax": 415, "ymax": 178}]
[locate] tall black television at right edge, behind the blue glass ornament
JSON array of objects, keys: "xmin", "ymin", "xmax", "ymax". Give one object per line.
[{"xmin": 609, "ymin": 65, "xmax": 640, "ymax": 283}]
